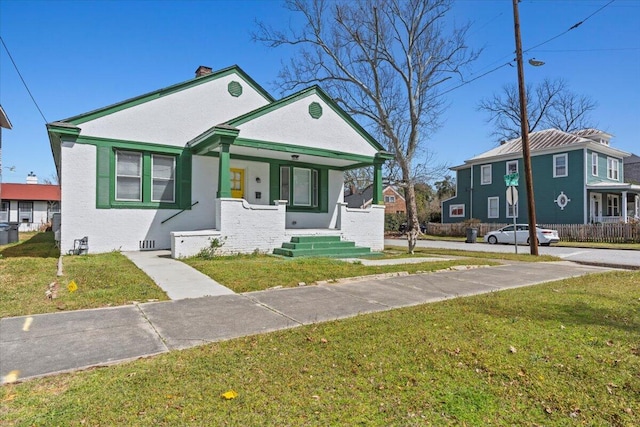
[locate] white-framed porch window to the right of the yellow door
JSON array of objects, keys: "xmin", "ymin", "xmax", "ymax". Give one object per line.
[{"xmin": 280, "ymin": 166, "xmax": 320, "ymax": 209}]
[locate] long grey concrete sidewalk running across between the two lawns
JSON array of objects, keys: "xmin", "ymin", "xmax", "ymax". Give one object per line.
[{"xmin": 0, "ymin": 256, "xmax": 610, "ymax": 382}]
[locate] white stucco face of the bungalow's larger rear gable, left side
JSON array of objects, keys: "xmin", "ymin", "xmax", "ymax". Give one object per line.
[{"xmin": 78, "ymin": 74, "xmax": 268, "ymax": 146}]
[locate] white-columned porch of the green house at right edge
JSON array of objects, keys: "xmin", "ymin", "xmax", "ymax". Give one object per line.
[{"xmin": 587, "ymin": 183, "xmax": 640, "ymax": 224}]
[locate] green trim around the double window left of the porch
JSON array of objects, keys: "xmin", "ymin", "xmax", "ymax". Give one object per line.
[{"xmin": 96, "ymin": 144, "xmax": 192, "ymax": 209}]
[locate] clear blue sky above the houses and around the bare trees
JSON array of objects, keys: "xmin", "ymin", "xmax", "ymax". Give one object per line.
[{"xmin": 0, "ymin": 0, "xmax": 640, "ymax": 182}]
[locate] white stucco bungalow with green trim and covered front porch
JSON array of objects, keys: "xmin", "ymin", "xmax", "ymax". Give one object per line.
[{"xmin": 47, "ymin": 66, "xmax": 391, "ymax": 257}]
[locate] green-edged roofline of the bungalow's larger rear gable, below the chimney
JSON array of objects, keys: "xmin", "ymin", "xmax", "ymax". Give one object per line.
[{"xmin": 55, "ymin": 65, "xmax": 274, "ymax": 125}]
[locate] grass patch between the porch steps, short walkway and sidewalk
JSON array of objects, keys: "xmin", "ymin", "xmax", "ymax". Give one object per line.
[{"xmin": 183, "ymin": 251, "xmax": 496, "ymax": 293}]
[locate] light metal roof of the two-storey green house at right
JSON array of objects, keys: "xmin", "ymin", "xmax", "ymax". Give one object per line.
[{"xmin": 465, "ymin": 129, "xmax": 629, "ymax": 163}]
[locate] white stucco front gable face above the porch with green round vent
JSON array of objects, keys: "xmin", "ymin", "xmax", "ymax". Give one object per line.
[{"xmin": 238, "ymin": 94, "xmax": 377, "ymax": 156}]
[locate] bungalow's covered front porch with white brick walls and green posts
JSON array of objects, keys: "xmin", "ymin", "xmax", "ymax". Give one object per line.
[{"xmin": 171, "ymin": 118, "xmax": 391, "ymax": 258}]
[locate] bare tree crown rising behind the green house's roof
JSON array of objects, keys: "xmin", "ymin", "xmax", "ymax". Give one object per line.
[{"xmin": 478, "ymin": 79, "xmax": 597, "ymax": 140}]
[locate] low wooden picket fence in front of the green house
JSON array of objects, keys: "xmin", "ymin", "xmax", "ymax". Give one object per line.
[{"xmin": 427, "ymin": 222, "xmax": 640, "ymax": 243}]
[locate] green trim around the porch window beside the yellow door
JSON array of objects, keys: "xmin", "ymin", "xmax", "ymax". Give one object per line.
[{"xmin": 269, "ymin": 163, "xmax": 329, "ymax": 213}]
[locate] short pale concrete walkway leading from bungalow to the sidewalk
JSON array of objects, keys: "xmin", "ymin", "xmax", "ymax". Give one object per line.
[{"xmin": 122, "ymin": 251, "xmax": 234, "ymax": 300}]
